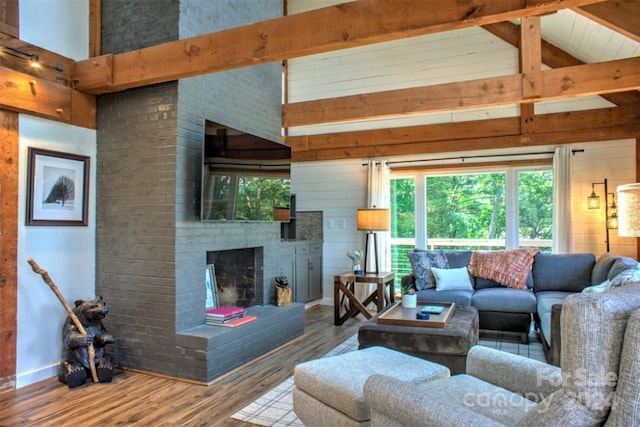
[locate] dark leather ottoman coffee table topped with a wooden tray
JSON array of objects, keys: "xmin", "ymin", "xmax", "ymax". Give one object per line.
[{"xmin": 358, "ymin": 302, "xmax": 478, "ymax": 375}]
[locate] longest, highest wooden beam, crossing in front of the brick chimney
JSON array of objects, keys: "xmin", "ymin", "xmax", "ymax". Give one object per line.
[{"xmin": 77, "ymin": 0, "xmax": 602, "ymax": 94}]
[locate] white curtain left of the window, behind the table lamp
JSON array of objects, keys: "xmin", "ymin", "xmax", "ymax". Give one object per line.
[{"xmin": 367, "ymin": 160, "xmax": 391, "ymax": 271}]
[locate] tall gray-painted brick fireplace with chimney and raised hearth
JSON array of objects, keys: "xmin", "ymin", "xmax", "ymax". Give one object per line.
[{"xmin": 96, "ymin": 0, "xmax": 304, "ymax": 383}]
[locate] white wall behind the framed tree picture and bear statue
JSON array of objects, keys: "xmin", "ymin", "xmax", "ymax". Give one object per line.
[{"xmin": 16, "ymin": 0, "xmax": 96, "ymax": 387}]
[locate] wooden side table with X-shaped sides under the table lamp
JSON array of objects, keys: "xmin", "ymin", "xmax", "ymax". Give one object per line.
[{"xmin": 333, "ymin": 272, "xmax": 395, "ymax": 325}]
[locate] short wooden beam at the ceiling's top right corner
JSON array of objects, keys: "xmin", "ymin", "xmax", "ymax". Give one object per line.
[{"xmin": 574, "ymin": 0, "xmax": 640, "ymax": 42}]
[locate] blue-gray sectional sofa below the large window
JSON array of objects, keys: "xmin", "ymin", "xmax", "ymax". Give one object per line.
[{"xmin": 401, "ymin": 250, "xmax": 640, "ymax": 365}]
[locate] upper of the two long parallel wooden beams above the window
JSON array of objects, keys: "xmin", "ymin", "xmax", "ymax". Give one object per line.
[{"xmin": 282, "ymin": 57, "xmax": 640, "ymax": 128}]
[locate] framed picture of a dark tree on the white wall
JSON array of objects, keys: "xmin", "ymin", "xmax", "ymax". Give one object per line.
[{"xmin": 27, "ymin": 147, "xmax": 89, "ymax": 226}]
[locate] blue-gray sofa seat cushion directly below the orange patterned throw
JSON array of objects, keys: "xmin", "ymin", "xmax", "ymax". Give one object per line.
[{"xmin": 471, "ymin": 287, "xmax": 536, "ymax": 313}]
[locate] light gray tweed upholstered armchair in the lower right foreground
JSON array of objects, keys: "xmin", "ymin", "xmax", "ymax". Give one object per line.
[{"xmin": 364, "ymin": 283, "xmax": 640, "ymax": 427}]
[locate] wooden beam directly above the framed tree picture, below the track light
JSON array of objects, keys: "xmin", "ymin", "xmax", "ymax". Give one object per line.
[{"xmin": 0, "ymin": 67, "xmax": 96, "ymax": 129}]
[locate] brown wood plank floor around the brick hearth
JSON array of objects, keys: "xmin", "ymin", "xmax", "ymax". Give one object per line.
[{"xmin": 0, "ymin": 305, "xmax": 365, "ymax": 427}]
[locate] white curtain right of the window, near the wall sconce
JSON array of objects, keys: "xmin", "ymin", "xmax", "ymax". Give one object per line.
[{"xmin": 553, "ymin": 146, "xmax": 573, "ymax": 254}]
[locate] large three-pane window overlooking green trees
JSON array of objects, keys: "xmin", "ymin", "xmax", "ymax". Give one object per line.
[{"xmin": 391, "ymin": 166, "xmax": 553, "ymax": 274}]
